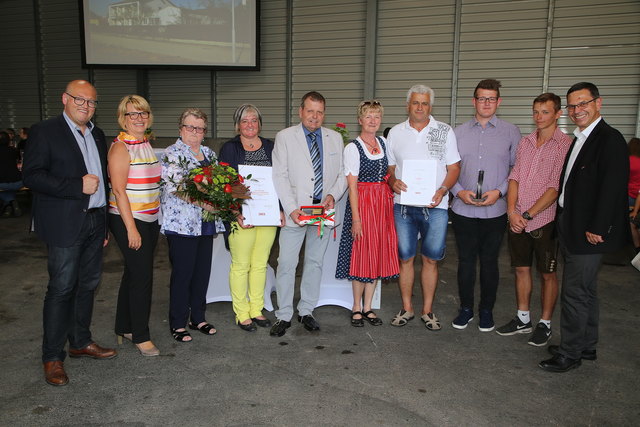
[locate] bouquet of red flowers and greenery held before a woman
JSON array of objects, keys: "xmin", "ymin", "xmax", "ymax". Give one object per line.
[{"xmin": 171, "ymin": 158, "xmax": 251, "ymax": 222}]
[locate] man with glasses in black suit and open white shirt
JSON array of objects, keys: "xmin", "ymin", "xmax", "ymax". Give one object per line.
[{"xmin": 539, "ymin": 82, "xmax": 629, "ymax": 372}]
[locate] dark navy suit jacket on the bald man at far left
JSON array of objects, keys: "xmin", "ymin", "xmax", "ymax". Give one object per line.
[{"xmin": 23, "ymin": 115, "xmax": 109, "ymax": 247}]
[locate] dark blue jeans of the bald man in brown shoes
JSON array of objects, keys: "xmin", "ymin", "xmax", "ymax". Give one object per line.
[{"xmin": 42, "ymin": 208, "xmax": 105, "ymax": 362}]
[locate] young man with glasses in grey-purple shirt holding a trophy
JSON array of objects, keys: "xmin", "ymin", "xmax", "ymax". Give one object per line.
[{"xmin": 451, "ymin": 79, "xmax": 522, "ymax": 332}]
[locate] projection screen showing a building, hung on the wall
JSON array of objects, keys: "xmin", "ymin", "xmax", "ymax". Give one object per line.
[{"xmin": 79, "ymin": 0, "xmax": 259, "ymax": 70}]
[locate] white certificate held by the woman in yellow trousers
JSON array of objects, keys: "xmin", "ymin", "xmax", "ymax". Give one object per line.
[{"xmin": 238, "ymin": 165, "xmax": 280, "ymax": 226}]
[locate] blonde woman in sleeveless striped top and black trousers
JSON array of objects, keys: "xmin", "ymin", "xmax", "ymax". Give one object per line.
[{"xmin": 108, "ymin": 95, "xmax": 161, "ymax": 356}]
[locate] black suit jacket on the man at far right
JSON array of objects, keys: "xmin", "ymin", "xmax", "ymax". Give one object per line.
[{"xmin": 558, "ymin": 119, "xmax": 629, "ymax": 254}]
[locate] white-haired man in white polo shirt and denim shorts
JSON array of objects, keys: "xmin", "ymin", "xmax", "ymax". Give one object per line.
[{"xmin": 387, "ymin": 85, "xmax": 460, "ymax": 331}]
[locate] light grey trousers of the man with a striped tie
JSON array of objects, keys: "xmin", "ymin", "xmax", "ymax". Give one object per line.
[{"xmin": 276, "ymin": 225, "xmax": 333, "ymax": 321}]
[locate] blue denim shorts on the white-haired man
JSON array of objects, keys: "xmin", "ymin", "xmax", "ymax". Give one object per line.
[{"xmin": 393, "ymin": 203, "xmax": 449, "ymax": 261}]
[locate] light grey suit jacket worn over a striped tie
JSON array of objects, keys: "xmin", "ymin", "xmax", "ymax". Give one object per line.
[{"xmin": 273, "ymin": 124, "xmax": 347, "ymax": 227}]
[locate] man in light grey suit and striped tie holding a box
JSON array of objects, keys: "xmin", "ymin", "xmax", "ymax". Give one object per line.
[{"xmin": 270, "ymin": 92, "xmax": 347, "ymax": 337}]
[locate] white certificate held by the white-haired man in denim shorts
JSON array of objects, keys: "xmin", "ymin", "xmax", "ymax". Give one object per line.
[{"xmin": 400, "ymin": 159, "xmax": 438, "ymax": 206}]
